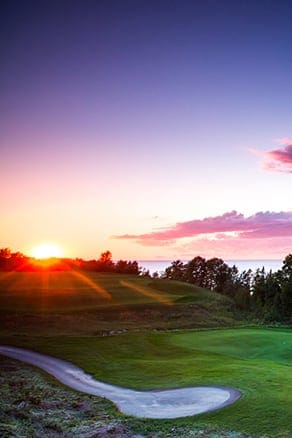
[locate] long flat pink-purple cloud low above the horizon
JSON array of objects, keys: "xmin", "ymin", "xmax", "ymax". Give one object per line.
[{"xmin": 114, "ymin": 211, "xmax": 292, "ymax": 246}]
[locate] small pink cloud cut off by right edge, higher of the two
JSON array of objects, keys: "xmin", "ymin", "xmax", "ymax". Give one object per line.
[{"xmin": 251, "ymin": 141, "xmax": 292, "ymax": 173}]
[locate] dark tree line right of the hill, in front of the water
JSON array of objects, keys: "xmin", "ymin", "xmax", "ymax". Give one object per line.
[{"xmin": 161, "ymin": 254, "xmax": 292, "ymax": 322}]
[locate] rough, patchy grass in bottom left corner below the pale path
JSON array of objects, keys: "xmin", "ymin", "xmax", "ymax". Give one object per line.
[{"xmin": 0, "ymin": 357, "xmax": 132, "ymax": 438}]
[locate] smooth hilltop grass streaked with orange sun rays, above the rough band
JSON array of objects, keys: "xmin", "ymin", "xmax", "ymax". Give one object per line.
[{"xmin": 0, "ymin": 271, "xmax": 233, "ymax": 313}]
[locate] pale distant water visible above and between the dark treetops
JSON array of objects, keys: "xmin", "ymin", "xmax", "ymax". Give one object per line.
[{"xmin": 138, "ymin": 260, "xmax": 283, "ymax": 274}]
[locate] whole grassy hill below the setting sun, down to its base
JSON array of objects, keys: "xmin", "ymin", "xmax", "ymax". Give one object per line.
[{"xmin": 0, "ymin": 271, "xmax": 237, "ymax": 335}]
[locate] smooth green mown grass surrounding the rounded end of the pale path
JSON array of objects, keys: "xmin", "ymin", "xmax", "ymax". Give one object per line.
[{"xmin": 0, "ymin": 329, "xmax": 292, "ymax": 437}]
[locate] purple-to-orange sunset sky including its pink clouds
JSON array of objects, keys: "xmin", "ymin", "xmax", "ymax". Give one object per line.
[{"xmin": 0, "ymin": 0, "xmax": 292, "ymax": 260}]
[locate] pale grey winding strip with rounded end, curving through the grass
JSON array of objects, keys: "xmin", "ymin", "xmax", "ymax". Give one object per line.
[{"xmin": 0, "ymin": 346, "xmax": 241, "ymax": 419}]
